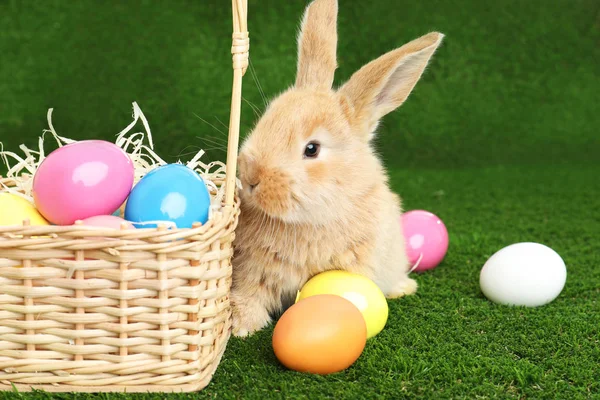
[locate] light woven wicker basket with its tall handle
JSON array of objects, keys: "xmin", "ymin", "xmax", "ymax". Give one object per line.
[{"xmin": 0, "ymin": 0, "xmax": 249, "ymax": 392}]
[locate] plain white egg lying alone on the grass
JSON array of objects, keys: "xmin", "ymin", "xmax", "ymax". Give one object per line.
[{"xmin": 479, "ymin": 242, "xmax": 567, "ymax": 307}]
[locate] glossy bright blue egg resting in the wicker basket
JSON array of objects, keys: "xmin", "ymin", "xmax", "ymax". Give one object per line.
[{"xmin": 125, "ymin": 164, "xmax": 210, "ymax": 228}]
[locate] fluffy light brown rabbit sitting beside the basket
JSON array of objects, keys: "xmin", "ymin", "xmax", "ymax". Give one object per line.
[{"xmin": 231, "ymin": 0, "xmax": 443, "ymax": 336}]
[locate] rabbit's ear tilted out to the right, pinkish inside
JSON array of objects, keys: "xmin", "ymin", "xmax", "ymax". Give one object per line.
[{"xmin": 339, "ymin": 32, "xmax": 444, "ymax": 134}]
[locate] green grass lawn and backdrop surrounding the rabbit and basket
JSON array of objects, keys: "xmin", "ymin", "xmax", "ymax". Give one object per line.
[{"xmin": 0, "ymin": 0, "xmax": 600, "ymax": 400}]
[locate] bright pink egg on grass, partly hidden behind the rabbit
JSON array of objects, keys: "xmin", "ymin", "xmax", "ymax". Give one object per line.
[{"xmin": 401, "ymin": 210, "xmax": 448, "ymax": 272}]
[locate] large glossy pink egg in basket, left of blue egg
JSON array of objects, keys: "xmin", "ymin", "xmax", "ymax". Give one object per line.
[{"xmin": 33, "ymin": 140, "xmax": 134, "ymax": 225}]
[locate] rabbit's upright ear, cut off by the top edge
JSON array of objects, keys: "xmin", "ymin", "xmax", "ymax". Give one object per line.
[{"xmin": 296, "ymin": 0, "xmax": 338, "ymax": 90}]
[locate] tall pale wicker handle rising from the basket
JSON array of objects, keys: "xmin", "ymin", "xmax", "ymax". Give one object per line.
[{"xmin": 225, "ymin": 0, "xmax": 250, "ymax": 206}]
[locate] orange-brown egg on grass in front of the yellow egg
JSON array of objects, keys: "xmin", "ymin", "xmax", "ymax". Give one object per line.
[{"xmin": 273, "ymin": 294, "xmax": 367, "ymax": 375}]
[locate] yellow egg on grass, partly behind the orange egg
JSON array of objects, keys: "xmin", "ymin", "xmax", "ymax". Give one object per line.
[{"xmin": 296, "ymin": 271, "xmax": 388, "ymax": 338}]
